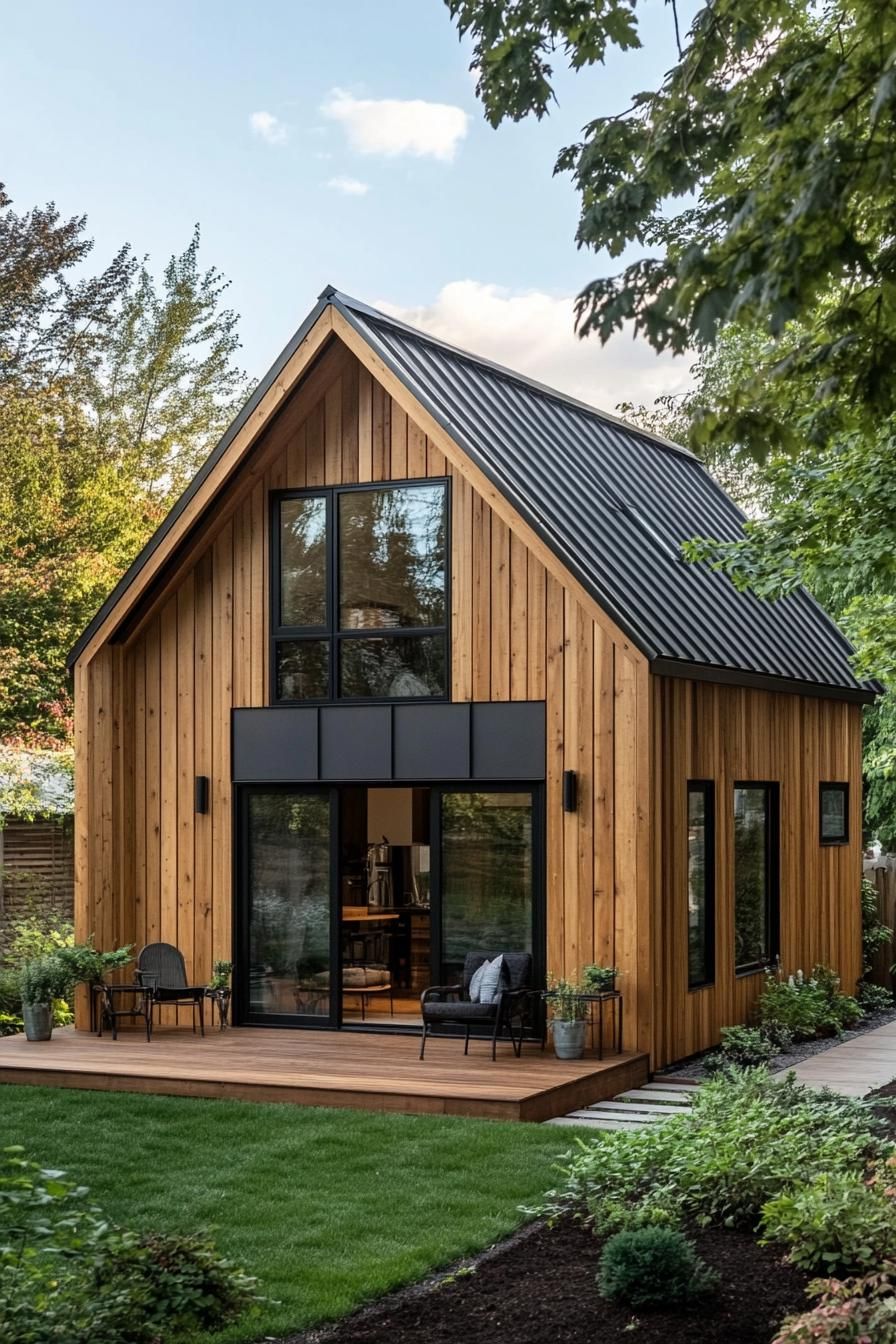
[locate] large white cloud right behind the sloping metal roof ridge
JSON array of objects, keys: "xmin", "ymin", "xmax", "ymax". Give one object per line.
[{"xmin": 376, "ymin": 280, "xmax": 690, "ymax": 413}]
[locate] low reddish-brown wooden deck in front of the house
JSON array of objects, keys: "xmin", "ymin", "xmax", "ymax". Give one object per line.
[{"xmin": 0, "ymin": 1027, "xmax": 647, "ymax": 1121}]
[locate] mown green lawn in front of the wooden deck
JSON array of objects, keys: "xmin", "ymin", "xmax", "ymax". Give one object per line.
[{"xmin": 0, "ymin": 1086, "xmax": 568, "ymax": 1341}]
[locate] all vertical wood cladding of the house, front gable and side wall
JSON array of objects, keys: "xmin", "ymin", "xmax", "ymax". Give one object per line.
[{"xmin": 75, "ymin": 333, "xmax": 861, "ymax": 1063}]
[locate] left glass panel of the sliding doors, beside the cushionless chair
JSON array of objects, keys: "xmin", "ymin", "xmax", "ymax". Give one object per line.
[{"xmin": 249, "ymin": 793, "xmax": 330, "ymax": 1012}]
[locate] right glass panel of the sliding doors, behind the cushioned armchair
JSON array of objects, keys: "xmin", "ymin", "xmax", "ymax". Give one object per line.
[{"xmin": 442, "ymin": 792, "xmax": 532, "ymax": 977}]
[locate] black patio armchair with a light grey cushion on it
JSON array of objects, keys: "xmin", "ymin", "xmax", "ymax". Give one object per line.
[{"xmin": 420, "ymin": 952, "xmax": 532, "ymax": 1059}]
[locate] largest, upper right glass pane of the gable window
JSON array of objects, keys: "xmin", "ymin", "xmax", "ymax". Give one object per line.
[{"xmin": 339, "ymin": 485, "xmax": 445, "ymax": 630}]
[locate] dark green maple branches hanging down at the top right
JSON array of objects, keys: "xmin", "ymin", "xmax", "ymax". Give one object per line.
[{"xmin": 446, "ymin": 0, "xmax": 896, "ymax": 446}]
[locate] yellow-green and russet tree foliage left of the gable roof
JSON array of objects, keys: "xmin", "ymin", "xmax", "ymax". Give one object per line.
[{"xmin": 0, "ymin": 188, "xmax": 246, "ymax": 746}]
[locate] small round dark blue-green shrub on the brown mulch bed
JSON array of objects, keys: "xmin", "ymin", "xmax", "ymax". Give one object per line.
[{"xmin": 598, "ymin": 1227, "xmax": 719, "ymax": 1306}]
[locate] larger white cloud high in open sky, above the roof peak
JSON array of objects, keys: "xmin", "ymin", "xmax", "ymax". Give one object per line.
[{"xmin": 321, "ymin": 89, "xmax": 470, "ymax": 163}]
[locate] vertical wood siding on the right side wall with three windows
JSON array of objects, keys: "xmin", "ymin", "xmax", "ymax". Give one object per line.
[{"xmin": 653, "ymin": 677, "xmax": 861, "ymax": 1064}]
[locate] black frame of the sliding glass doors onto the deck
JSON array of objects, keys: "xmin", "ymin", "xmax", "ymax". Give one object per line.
[{"xmin": 231, "ymin": 780, "xmax": 547, "ymax": 1034}]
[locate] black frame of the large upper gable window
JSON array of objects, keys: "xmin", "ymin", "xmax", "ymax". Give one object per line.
[{"xmin": 267, "ymin": 476, "xmax": 451, "ymax": 704}]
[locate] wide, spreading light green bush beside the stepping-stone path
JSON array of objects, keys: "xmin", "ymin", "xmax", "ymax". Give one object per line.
[{"xmin": 539, "ymin": 1068, "xmax": 892, "ymax": 1235}]
